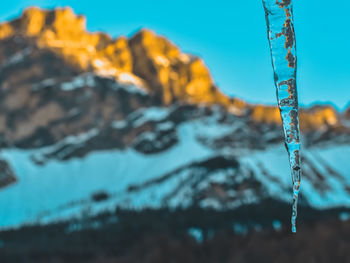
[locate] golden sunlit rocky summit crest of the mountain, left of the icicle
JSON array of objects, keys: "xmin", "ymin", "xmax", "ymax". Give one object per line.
[{"xmin": 0, "ymin": 7, "xmax": 244, "ymax": 108}]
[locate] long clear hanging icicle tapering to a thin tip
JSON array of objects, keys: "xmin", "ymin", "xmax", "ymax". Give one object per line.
[{"xmin": 263, "ymin": 0, "xmax": 301, "ymax": 233}]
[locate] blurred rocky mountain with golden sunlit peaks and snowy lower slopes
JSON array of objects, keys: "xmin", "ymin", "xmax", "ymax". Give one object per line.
[{"xmin": 0, "ymin": 5, "xmax": 350, "ymax": 228}]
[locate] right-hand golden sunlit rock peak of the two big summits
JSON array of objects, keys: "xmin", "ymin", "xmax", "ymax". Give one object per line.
[{"xmin": 129, "ymin": 30, "xmax": 239, "ymax": 106}]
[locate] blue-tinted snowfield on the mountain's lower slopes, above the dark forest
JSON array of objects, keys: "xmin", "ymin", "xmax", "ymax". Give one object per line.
[{"xmin": 0, "ymin": 107, "xmax": 350, "ymax": 228}]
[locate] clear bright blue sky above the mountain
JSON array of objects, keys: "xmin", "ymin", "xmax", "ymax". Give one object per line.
[{"xmin": 0, "ymin": 0, "xmax": 350, "ymax": 109}]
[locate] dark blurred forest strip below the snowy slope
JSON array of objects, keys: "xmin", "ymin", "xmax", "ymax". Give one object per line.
[{"xmin": 0, "ymin": 200, "xmax": 350, "ymax": 263}]
